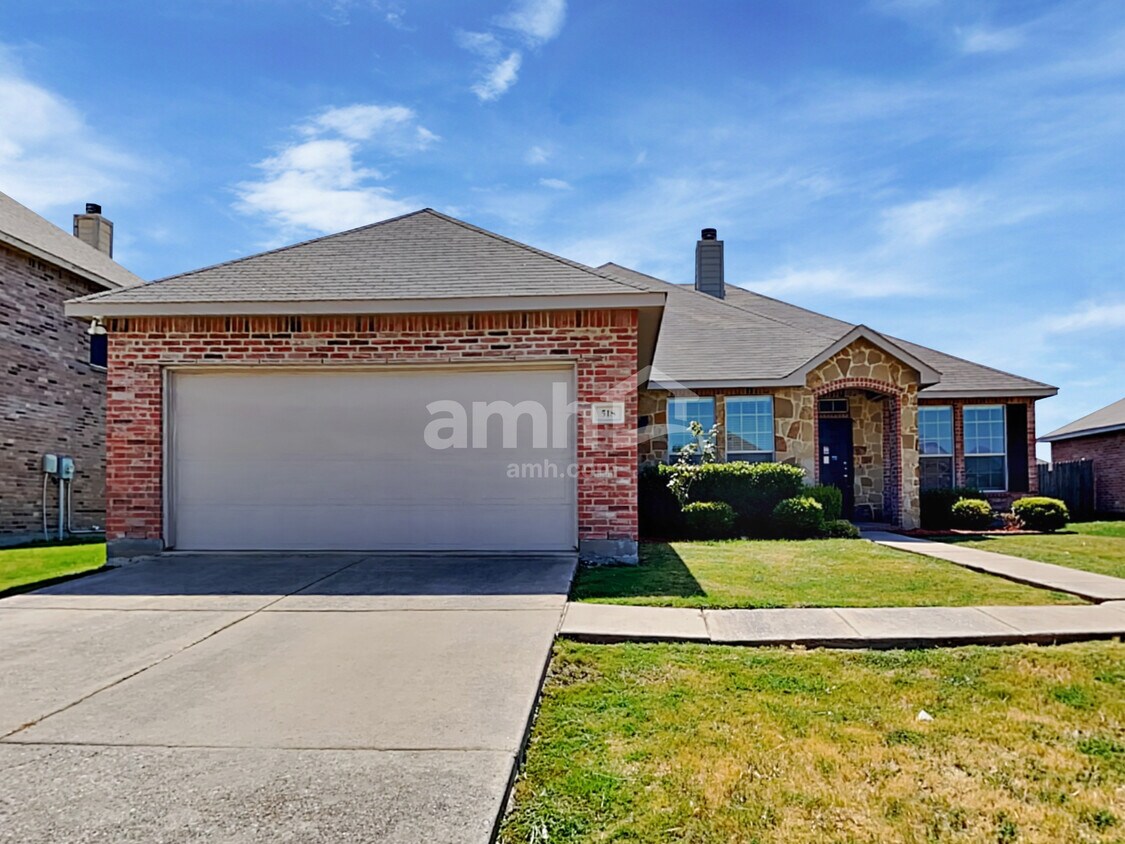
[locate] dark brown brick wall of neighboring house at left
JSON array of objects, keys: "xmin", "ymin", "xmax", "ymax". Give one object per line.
[{"xmin": 0, "ymin": 246, "xmax": 106, "ymax": 535}]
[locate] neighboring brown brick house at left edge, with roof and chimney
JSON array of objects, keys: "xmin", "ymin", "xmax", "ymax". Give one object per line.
[{"xmin": 0, "ymin": 194, "xmax": 142, "ymax": 541}]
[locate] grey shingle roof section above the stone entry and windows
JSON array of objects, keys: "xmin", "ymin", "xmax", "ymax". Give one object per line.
[{"xmin": 600, "ymin": 263, "xmax": 1058, "ymax": 398}]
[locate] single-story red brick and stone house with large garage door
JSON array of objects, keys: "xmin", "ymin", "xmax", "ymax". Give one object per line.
[{"xmin": 68, "ymin": 209, "xmax": 1055, "ymax": 558}]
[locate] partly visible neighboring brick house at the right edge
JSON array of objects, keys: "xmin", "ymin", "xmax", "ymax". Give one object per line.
[{"xmin": 1040, "ymin": 398, "xmax": 1125, "ymax": 513}]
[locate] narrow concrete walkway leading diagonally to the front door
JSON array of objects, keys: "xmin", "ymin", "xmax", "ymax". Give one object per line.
[{"xmin": 863, "ymin": 530, "xmax": 1125, "ymax": 602}]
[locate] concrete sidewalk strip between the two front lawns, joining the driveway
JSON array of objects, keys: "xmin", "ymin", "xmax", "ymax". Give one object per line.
[{"xmin": 559, "ymin": 601, "xmax": 1125, "ymax": 648}]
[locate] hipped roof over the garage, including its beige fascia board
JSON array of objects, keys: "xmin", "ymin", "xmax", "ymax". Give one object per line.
[{"xmin": 68, "ymin": 208, "xmax": 664, "ymax": 316}]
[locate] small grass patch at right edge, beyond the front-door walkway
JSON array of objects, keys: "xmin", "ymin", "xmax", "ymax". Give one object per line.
[{"xmin": 943, "ymin": 521, "xmax": 1125, "ymax": 577}]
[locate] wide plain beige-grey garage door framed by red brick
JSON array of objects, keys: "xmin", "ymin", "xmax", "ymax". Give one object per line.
[{"xmin": 169, "ymin": 368, "xmax": 577, "ymax": 550}]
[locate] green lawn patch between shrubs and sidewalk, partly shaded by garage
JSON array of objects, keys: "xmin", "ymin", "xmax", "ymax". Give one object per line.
[{"xmin": 572, "ymin": 539, "xmax": 1082, "ymax": 608}]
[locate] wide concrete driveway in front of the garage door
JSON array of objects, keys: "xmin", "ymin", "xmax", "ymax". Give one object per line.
[{"xmin": 0, "ymin": 555, "xmax": 575, "ymax": 844}]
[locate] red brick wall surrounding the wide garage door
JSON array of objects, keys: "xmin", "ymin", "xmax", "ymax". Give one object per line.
[{"xmin": 107, "ymin": 311, "xmax": 637, "ymax": 549}]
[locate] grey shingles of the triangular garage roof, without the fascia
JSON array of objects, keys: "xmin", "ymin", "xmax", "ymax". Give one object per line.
[{"xmin": 72, "ymin": 208, "xmax": 648, "ymax": 304}]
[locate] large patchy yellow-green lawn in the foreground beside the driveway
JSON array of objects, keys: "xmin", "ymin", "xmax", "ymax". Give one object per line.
[{"xmin": 501, "ymin": 641, "xmax": 1125, "ymax": 844}]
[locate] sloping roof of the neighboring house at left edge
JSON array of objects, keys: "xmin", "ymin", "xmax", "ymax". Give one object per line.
[{"xmin": 0, "ymin": 191, "xmax": 144, "ymax": 290}]
